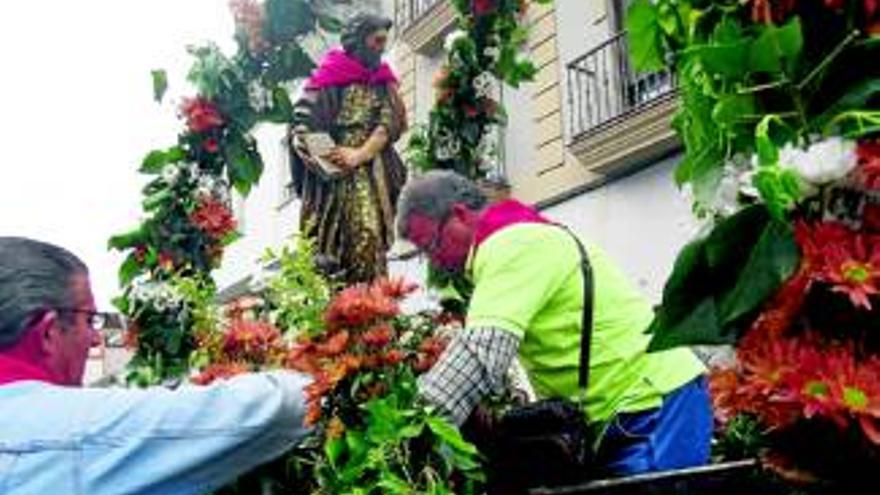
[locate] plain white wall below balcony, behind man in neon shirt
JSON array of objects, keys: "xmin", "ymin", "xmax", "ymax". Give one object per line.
[{"xmin": 544, "ymin": 157, "xmax": 696, "ymax": 301}]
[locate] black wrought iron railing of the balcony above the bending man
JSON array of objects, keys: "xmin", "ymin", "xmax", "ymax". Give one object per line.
[{"xmin": 566, "ymin": 32, "xmax": 675, "ymax": 140}]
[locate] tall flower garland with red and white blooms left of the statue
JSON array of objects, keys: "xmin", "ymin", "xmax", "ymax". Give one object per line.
[{"xmin": 110, "ymin": 0, "xmax": 338, "ymax": 384}]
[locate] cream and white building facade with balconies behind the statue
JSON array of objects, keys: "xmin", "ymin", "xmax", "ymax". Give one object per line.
[{"xmin": 218, "ymin": 0, "xmax": 694, "ymax": 306}]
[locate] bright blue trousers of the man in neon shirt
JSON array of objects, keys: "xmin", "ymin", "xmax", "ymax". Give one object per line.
[{"xmin": 598, "ymin": 376, "xmax": 712, "ymax": 476}]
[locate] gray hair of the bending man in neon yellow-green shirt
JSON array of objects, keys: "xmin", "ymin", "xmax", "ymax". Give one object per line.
[{"xmin": 397, "ymin": 170, "xmax": 488, "ymax": 239}]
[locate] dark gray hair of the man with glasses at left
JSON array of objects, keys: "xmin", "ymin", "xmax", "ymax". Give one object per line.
[{"xmin": 0, "ymin": 237, "xmax": 88, "ymax": 349}]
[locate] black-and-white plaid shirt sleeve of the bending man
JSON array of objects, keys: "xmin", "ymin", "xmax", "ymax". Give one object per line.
[{"xmin": 419, "ymin": 327, "xmax": 520, "ymax": 426}]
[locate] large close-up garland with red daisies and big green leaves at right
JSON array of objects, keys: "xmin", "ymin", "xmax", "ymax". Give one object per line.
[{"xmin": 628, "ymin": 0, "xmax": 880, "ymax": 483}]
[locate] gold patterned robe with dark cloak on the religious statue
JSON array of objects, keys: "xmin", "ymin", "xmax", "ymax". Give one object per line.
[{"xmin": 291, "ymin": 84, "xmax": 406, "ymax": 283}]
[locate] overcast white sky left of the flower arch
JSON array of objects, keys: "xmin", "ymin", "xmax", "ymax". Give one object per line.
[{"xmin": 0, "ymin": 0, "xmax": 233, "ymax": 308}]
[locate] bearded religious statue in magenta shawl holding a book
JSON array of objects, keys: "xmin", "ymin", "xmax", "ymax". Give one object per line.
[{"xmin": 290, "ymin": 14, "xmax": 407, "ymax": 283}]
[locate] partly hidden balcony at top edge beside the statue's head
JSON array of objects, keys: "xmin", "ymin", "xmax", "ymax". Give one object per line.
[{"xmin": 394, "ymin": 0, "xmax": 456, "ymax": 53}]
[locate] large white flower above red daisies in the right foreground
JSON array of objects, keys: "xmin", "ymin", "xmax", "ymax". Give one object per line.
[{"xmin": 779, "ymin": 137, "xmax": 857, "ymax": 186}]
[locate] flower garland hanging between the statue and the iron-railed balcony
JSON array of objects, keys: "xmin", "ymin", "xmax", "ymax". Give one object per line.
[{"xmin": 407, "ymin": 0, "xmax": 551, "ymax": 179}]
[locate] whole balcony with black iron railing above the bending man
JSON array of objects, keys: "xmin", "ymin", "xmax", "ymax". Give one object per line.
[{"xmin": 566, "ymin": 33, "xmax": 678, "ymax": 174}]
